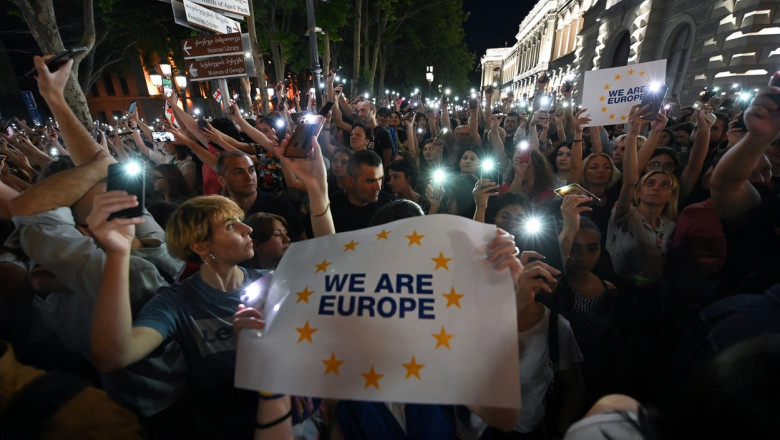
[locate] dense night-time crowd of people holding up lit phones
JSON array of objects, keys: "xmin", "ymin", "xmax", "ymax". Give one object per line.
[{"xmin": 0, "ymin": 52, "xmax": 780, "ymax": 439}]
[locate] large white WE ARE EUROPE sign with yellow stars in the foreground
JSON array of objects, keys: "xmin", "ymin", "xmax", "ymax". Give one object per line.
[{"xmin": 236, "ymin": 215, "xmax": 520, "ymax": 408}]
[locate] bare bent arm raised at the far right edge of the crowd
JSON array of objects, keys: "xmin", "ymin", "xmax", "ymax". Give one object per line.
[{"xmin": 710, "ymin": 72, "xmax": 780, "ymax": 222}]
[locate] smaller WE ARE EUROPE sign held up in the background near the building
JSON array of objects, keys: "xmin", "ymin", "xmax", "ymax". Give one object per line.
[{"xmin": 582, "ymin": 60, "xmax": 666, "ymax": 126}]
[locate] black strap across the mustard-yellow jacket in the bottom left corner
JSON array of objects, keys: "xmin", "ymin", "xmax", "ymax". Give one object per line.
[{"xmin": 0, "ymin": 371, "xmax": 90, "ymax": 440}]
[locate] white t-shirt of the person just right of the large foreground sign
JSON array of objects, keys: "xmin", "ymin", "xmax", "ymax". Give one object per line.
[{"xmin": 514, "ymin": 307, "xmax": 582, "ymax": 433}]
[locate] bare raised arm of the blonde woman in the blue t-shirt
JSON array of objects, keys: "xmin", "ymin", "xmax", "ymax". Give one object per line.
[{"xmin": 87, "ymin": 191, "xmax": 163, "ymax": 372}]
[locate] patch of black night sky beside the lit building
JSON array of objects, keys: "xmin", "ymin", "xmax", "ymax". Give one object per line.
[{"xmin": 463, "ymin": 0, "xmax": 536, "ymax": 82}]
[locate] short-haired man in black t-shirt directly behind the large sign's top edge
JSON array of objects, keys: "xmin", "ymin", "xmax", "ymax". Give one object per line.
[{"xmin": 330, "ymin": 150, "xmax": 394, "ymax": 232}]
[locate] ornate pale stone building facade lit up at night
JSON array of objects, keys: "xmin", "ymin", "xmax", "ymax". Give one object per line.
[{"xmin": 481, "ymin": 0, "xmax": 780, "ymax": 105}]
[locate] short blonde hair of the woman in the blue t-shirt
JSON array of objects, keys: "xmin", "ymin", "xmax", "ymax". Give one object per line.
[{"xmin": 165, "ymin": 195, "xmax": 244, "ymax": 263}]
